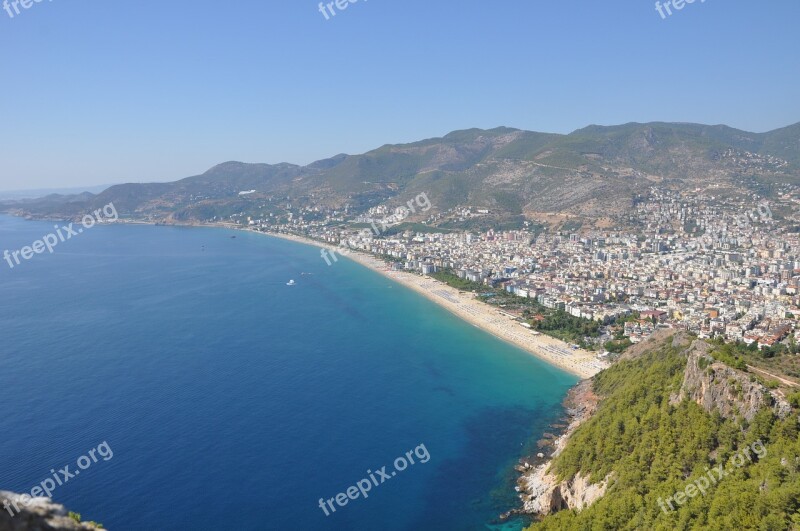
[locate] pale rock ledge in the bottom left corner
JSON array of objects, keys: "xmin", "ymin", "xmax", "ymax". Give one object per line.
[{"xmin": 0, "ymin": 491, "xmax": 97, "ymax": 531}]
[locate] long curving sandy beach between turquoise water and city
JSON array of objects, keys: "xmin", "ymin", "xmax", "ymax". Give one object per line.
[{"xmin": 262, "ymin": 231, "xmax": 608, "ymax": 378}]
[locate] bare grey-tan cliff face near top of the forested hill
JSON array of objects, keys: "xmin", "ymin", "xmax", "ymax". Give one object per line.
[{"xmin": 671, "ymin": 341, "xmax": 791, "ymax": 421}]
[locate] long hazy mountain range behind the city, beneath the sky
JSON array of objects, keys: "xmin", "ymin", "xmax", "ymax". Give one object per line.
[{"xmin": 0, "ymin": 123, "xmax": 800, "ymax": 227}]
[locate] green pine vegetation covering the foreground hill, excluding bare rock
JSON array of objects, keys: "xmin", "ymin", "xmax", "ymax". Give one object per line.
[{"xmin": 531, "ymin": 343, "xmax": 800, "ymax": 531}]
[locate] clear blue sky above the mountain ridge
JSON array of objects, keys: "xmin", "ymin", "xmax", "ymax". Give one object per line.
[{"xmin": 0, "ymin": 0, "xmax": 800, "ymax": 190}]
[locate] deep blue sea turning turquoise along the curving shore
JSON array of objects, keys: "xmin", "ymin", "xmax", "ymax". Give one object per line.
[{"xmin": 0, "ymin": 217, "xmax": 576, "ymax": 530}]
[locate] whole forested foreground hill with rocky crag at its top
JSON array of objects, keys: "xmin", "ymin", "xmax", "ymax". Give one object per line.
[{"xmin": 531, "ymin": 336, "xmax": 800, "ymax": 531}]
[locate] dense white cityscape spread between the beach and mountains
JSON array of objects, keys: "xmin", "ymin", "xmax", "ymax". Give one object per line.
[{"xmin": 255, "ymin": 187, "xmax": 800, "ymax": 364}]
